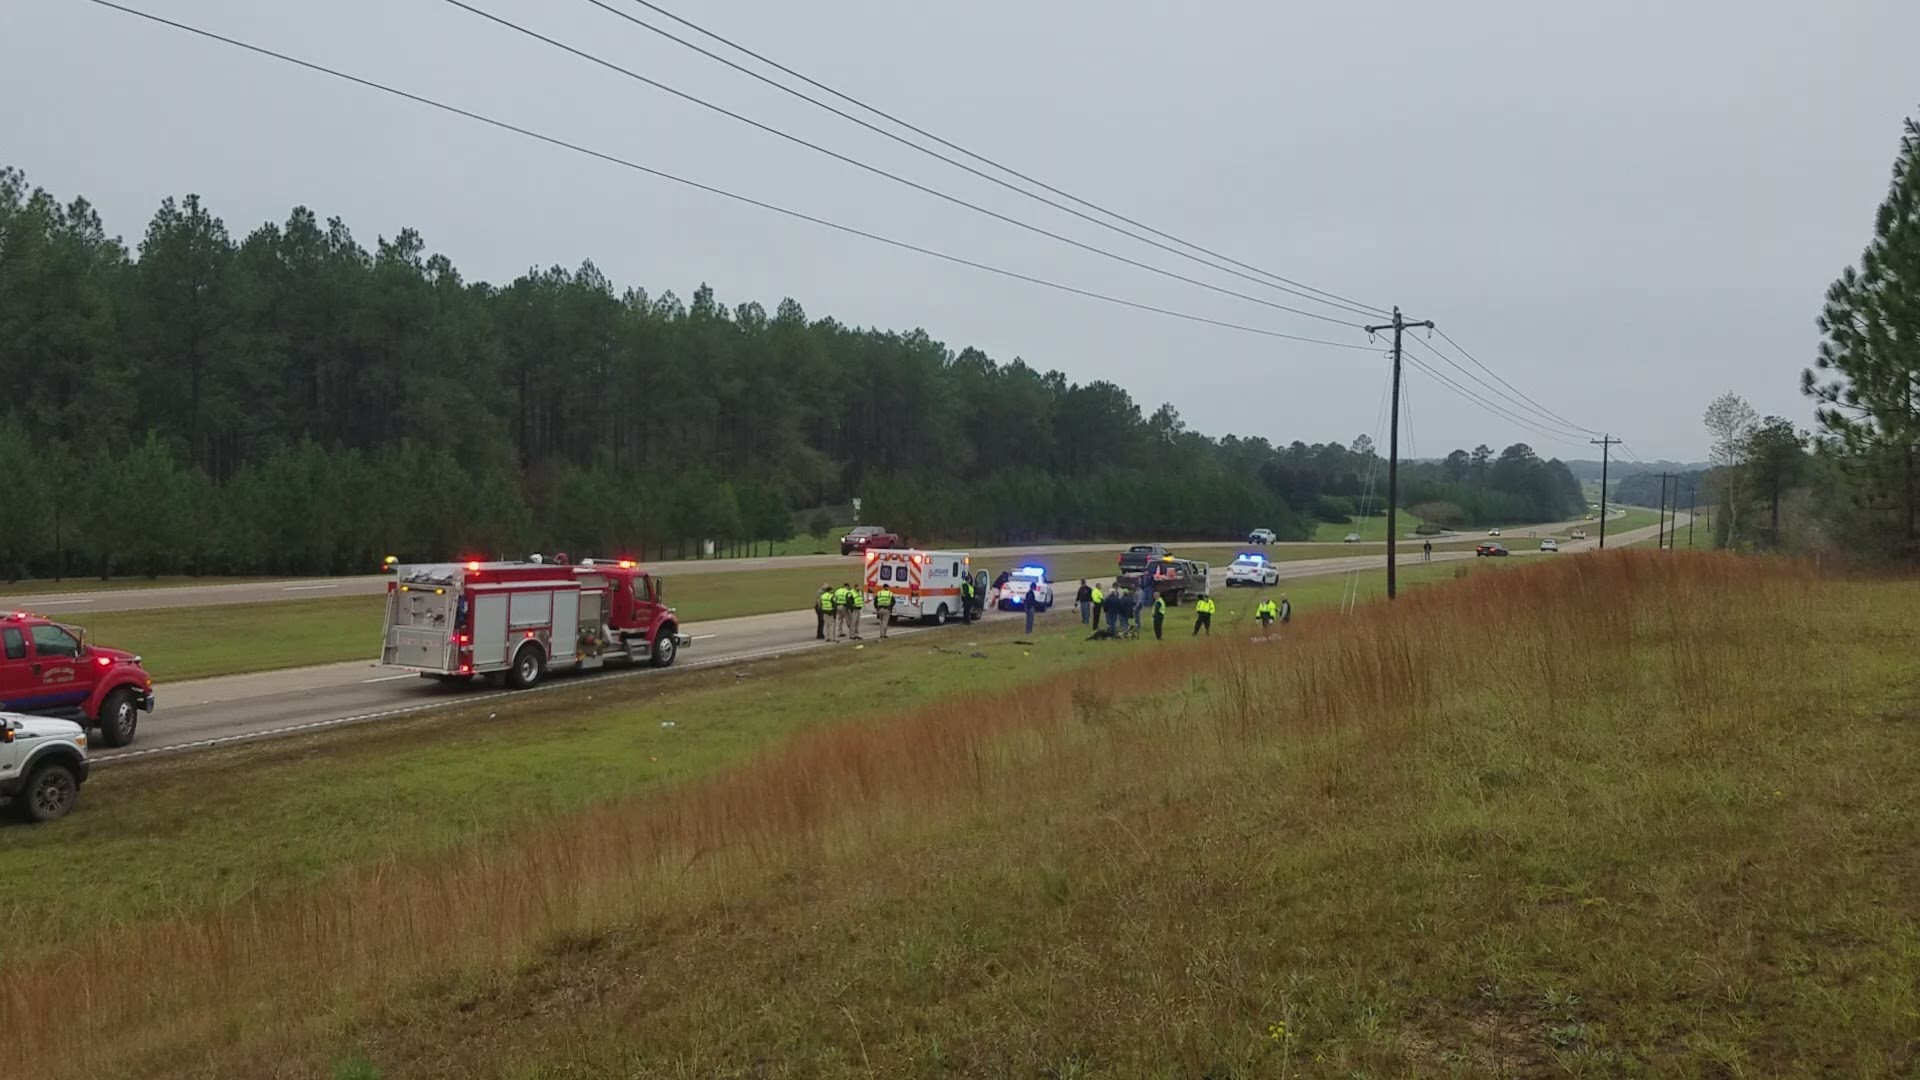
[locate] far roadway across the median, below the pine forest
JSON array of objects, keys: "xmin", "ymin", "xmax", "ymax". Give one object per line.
[{"xmin": 0, "ymin": 521, "xmax": 1628, "ymax": 617}]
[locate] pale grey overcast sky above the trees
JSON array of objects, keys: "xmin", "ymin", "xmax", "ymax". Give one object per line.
[{"xmin": 0, "ymin": 0, "xmax": 1920, "ymax": 459}]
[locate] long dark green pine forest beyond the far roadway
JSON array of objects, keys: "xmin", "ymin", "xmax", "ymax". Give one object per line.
[{"xmin": 0, "ymin": 169, "xmax": 1576, "ymax": 580}]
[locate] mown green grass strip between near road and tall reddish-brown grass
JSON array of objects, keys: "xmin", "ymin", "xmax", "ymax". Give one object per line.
[{"xmin": 0, "ymin": 567, "xmax": 1478, "ymax": 945}]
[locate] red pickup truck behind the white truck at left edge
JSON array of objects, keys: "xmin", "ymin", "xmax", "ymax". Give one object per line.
[{"xmin": 0, "ymin": 611, "xmax": 154, "ymax": 746}]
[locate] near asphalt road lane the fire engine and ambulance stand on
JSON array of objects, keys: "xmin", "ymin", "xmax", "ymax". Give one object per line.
[{"xmin": 94, "ymin": 517, "xmax": 1686, "ymax": 765}]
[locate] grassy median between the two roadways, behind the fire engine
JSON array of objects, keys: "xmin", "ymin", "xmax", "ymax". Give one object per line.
[{"xmin": 56, "ymin": 542, "xmax": 1473, "ymax": 682}]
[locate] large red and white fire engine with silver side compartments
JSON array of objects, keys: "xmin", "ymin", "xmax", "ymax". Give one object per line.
[{"xmin": 380, "ymin": 559, "xmax": 693, "ymax": 690}]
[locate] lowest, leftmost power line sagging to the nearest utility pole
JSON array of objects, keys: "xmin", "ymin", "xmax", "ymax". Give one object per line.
[{"xmin": 88, "ymin": 0, "xmax": 1375, "ymax": 352}]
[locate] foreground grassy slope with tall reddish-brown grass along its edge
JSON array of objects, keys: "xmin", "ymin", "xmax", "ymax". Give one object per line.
[{"xmin": 15, "ymin": 552, "xmax": 1920, "ymax": 1078}]
